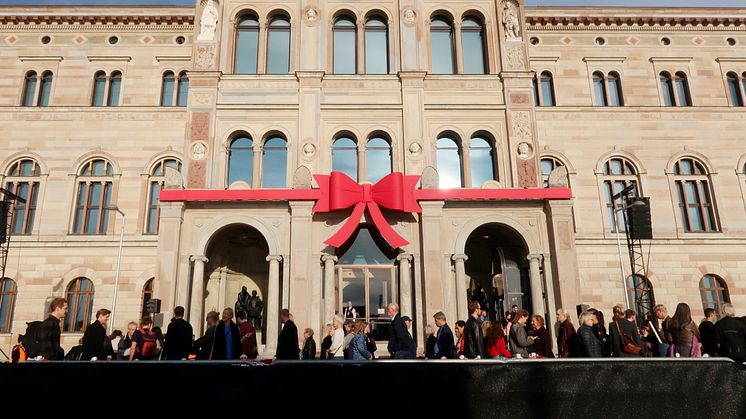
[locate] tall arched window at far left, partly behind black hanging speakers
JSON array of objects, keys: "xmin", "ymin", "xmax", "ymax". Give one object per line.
[{"xmin": 5, "ymin": 159, "xmax": 41, "ymax": 234}]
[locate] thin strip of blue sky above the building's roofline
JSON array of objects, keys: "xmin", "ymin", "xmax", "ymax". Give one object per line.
[{"xmin": 0, "ymin": 0, "xmax": 746, "ymax": 7}]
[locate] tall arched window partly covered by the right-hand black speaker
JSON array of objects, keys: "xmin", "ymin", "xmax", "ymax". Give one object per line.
[{"xmin": 603, "ymin": 157, "xmax": 640, "ymax": 232}]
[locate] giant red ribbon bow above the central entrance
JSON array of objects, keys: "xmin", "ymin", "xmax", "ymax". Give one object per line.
[{"xmin": 313, "ymin": 172, "xmax": 422, "ymax": 249}]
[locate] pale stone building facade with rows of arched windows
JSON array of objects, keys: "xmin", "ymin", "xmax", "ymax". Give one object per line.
[{"xmin": 0, "ymin": 0, "xmax": 746, "ymax": 354}]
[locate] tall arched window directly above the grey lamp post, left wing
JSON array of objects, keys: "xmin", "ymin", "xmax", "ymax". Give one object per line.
[{"xmin": 73, "ymin": 159, "xmax": 114, "ymax": 234}]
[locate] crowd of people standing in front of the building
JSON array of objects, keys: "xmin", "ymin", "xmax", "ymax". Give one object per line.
[{"xmin": 13, "ymin": 298, "xmax": 746, "ymax": 362}]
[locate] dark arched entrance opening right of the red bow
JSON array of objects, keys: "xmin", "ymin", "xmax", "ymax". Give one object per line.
[{"xmin": 460, "ymin": 223, "xmax": 532, "ymax": 320}]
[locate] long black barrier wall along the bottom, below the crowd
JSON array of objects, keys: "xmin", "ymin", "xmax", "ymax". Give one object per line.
[{"xmin": 0, "ymin": 359, "xmax": 746, "ymax": 419}]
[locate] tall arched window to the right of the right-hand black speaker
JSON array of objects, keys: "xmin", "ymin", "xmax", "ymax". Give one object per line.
[{"xmin": 674, "ymin": 157, "xmax": 719, "ymax": 232}]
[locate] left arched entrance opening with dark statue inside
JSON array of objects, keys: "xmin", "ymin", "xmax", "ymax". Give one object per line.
[{"xmin": 204, "ymin": 224, "xmax": 269, "ymax": 344}]
